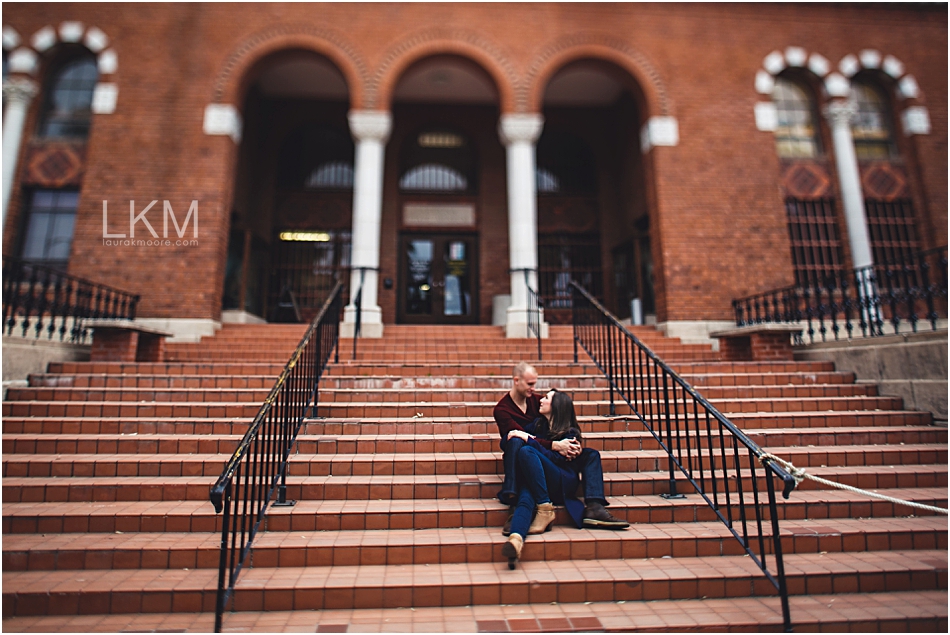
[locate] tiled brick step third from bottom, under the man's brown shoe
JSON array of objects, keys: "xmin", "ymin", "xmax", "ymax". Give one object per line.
[{"xmin": 9, "ymin": 517, "xmax": 947, "ymax": 572}]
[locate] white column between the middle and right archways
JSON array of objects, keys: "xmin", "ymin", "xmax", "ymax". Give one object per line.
[{"xmin": 498, "ymin": 113, "xmax": 546, "ymax": 337}]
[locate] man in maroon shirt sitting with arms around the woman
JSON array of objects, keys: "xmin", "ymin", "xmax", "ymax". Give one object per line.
[{"xmin": 494, "ymin": 362, "xmax": 629, "ymax": 535}]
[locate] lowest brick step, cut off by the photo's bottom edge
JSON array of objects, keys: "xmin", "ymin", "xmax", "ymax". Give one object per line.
[{"xmin": 3, "ymin": 591, "xmax": 947, "ymax": 633}]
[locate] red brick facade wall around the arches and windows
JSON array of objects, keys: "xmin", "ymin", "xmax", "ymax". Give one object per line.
[{"xmin": 3, "ymin": 3, "xmax": 948, "ymax": 322}]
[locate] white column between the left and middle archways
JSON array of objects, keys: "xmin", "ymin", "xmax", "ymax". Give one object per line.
[{"xmin": 341, "ymin": 110, "xmax": 392, "ymax": 337}]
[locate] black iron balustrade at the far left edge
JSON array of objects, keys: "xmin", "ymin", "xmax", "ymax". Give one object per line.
[{"xmin": 3, "ymin": 256, "xmax": 141, "ymax": 344}]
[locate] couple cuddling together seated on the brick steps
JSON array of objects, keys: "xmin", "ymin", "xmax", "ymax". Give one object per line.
[{"xmin": 494, "ymin": 362, "xmax": 629, "ymax": 569}]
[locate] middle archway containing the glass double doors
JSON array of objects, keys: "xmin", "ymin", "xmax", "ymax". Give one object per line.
[{"xmin": 380, "ymin": 55, "xmax": 507, "ymax": 324}]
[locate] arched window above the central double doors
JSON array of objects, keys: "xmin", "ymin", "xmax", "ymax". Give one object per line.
[{"xmin": 399, "ymin": 129, "xmax": 475, "ymax": 194}]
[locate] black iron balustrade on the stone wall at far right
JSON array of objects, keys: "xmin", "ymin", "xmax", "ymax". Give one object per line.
[{"xmin": 732, "ymin": 246, "xmax": 947, "ymax": 344}]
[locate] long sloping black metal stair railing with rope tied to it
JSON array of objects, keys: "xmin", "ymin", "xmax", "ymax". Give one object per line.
[{"xmin": 571, "ymin": 281, "xmax": 795, "ymax": 630}]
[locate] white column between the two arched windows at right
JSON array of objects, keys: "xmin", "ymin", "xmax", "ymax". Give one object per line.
[{"xmin": 825, "ymin": 100, "xmax": 873, "ymax": 267}]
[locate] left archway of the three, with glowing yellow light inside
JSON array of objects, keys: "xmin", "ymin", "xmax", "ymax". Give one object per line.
[{"xmin": 222, "ymin": 50, "xmax": 354, "ymax": 322}]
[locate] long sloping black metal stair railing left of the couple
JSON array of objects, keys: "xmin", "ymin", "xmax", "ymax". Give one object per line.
[{"xmin": 211, "ymin": 282, "xmax": 343, "ymax": 633}]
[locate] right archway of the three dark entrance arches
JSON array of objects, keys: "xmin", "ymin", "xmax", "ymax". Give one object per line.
[{"xmin": 537, "ymin": 59, "xmax": 656, "ymax": 323}]
